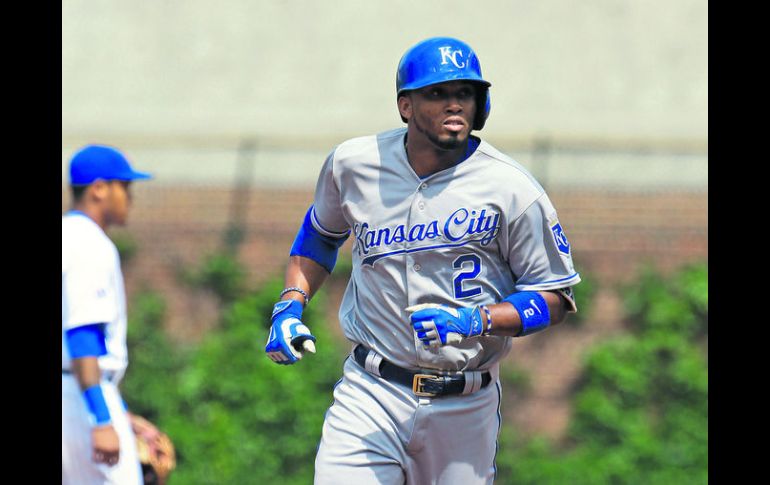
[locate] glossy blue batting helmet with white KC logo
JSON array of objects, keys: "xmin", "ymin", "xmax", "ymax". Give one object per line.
[{"xmin": 396, "ymin": 37, "xmax": 492, "ymax": 130}]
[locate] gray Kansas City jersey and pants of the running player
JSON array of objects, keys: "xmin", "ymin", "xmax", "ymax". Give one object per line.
[{"xmin": 311, "ymin": 128, "xmax": 580, "ymax": 485}]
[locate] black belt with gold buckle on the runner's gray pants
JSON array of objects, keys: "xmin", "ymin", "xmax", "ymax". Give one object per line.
[{"xmin": 353, "ymin": 345, "xmax": 492, "ymax": 397}]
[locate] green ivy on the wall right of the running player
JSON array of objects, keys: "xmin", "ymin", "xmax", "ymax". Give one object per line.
[{"xmin": 497, "ymin": 264, "xmax": 708, "ymax": 485}]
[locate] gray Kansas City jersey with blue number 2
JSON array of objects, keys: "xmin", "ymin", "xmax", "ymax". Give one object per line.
[{"xmin": 312, "ymin": 128, "xmax": 580, "ymax": 370}]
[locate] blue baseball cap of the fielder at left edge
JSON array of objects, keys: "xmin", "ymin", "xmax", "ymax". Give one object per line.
[{"xmin": 70, "ymin": 145, "xmax": 152, "ymax": 185}]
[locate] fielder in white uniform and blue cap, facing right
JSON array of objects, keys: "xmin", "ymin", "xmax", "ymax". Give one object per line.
[{"xmin": 61, "ymin": 145, "xmax": 159, "ymax": 485}]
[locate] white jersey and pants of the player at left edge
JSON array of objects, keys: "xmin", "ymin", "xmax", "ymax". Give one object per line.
[{"xmin": 62, "ymin": 212, "xmax": 142, "ymax": 485}]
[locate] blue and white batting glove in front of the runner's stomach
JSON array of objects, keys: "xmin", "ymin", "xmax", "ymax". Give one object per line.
[{"xmin": 406, "ymin": 303, "xmax": 484, "ymax": 347}]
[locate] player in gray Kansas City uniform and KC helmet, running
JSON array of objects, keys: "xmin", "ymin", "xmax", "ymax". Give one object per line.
[{"xmin": 266, "ymin": 37, "xmax": 580, "ymax": 485}]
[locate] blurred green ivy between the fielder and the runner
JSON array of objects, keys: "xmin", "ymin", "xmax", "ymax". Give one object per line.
[{"xmin": 122, "ymin": 244, "xmax": 347, "ymax": 485}]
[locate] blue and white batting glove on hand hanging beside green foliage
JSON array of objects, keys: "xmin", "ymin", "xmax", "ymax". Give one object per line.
[{"xmin": 265, "ymin": 300, "xmax": 315, "ymax": 365}]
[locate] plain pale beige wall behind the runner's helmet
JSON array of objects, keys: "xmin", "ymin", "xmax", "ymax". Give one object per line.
[{"xmin": 62, "ymin": 0, "xmax": 708, "ymax": 186}]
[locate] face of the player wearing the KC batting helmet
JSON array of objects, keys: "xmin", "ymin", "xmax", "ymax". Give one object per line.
[{"xmin": 402, "ymin": 81, "xmax": 477, "ymax": 150}]
